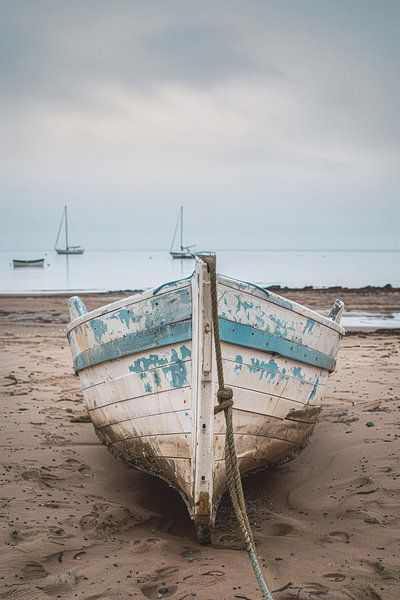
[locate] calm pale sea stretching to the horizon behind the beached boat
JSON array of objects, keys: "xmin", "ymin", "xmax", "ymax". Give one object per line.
[{"xmin": 0, "ymin": 250, "xmax": 400, "ymax": 293}]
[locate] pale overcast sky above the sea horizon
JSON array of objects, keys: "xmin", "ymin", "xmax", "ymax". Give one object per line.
[{"xmin": 0, "ymin": 0, "xmax": 400, "ymax": 249}]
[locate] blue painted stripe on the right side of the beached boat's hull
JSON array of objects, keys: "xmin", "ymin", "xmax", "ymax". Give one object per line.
[{"xmin": 219, "ymin": 319, "xmax": 336, "ymax": 371}]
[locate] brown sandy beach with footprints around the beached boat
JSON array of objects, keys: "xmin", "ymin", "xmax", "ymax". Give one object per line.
[{"xmin": 0, "ymin": 288, "xmax": 400, "ymax": 600}]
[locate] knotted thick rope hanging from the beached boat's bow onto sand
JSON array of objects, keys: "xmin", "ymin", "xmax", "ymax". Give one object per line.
[{"xmin": 201, "ymin": 254, "xmax": 273, "ymax": 600}]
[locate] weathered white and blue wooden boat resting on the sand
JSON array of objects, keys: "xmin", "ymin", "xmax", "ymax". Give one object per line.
[{"xmin": 68, "ymin": 257, "xmax": 344, "ymax": 541}]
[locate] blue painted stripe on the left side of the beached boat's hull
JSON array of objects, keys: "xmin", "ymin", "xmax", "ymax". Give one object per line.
[{"xmin": 74, "ymin": 319, "xmax": 192, "ymax": 371}]
